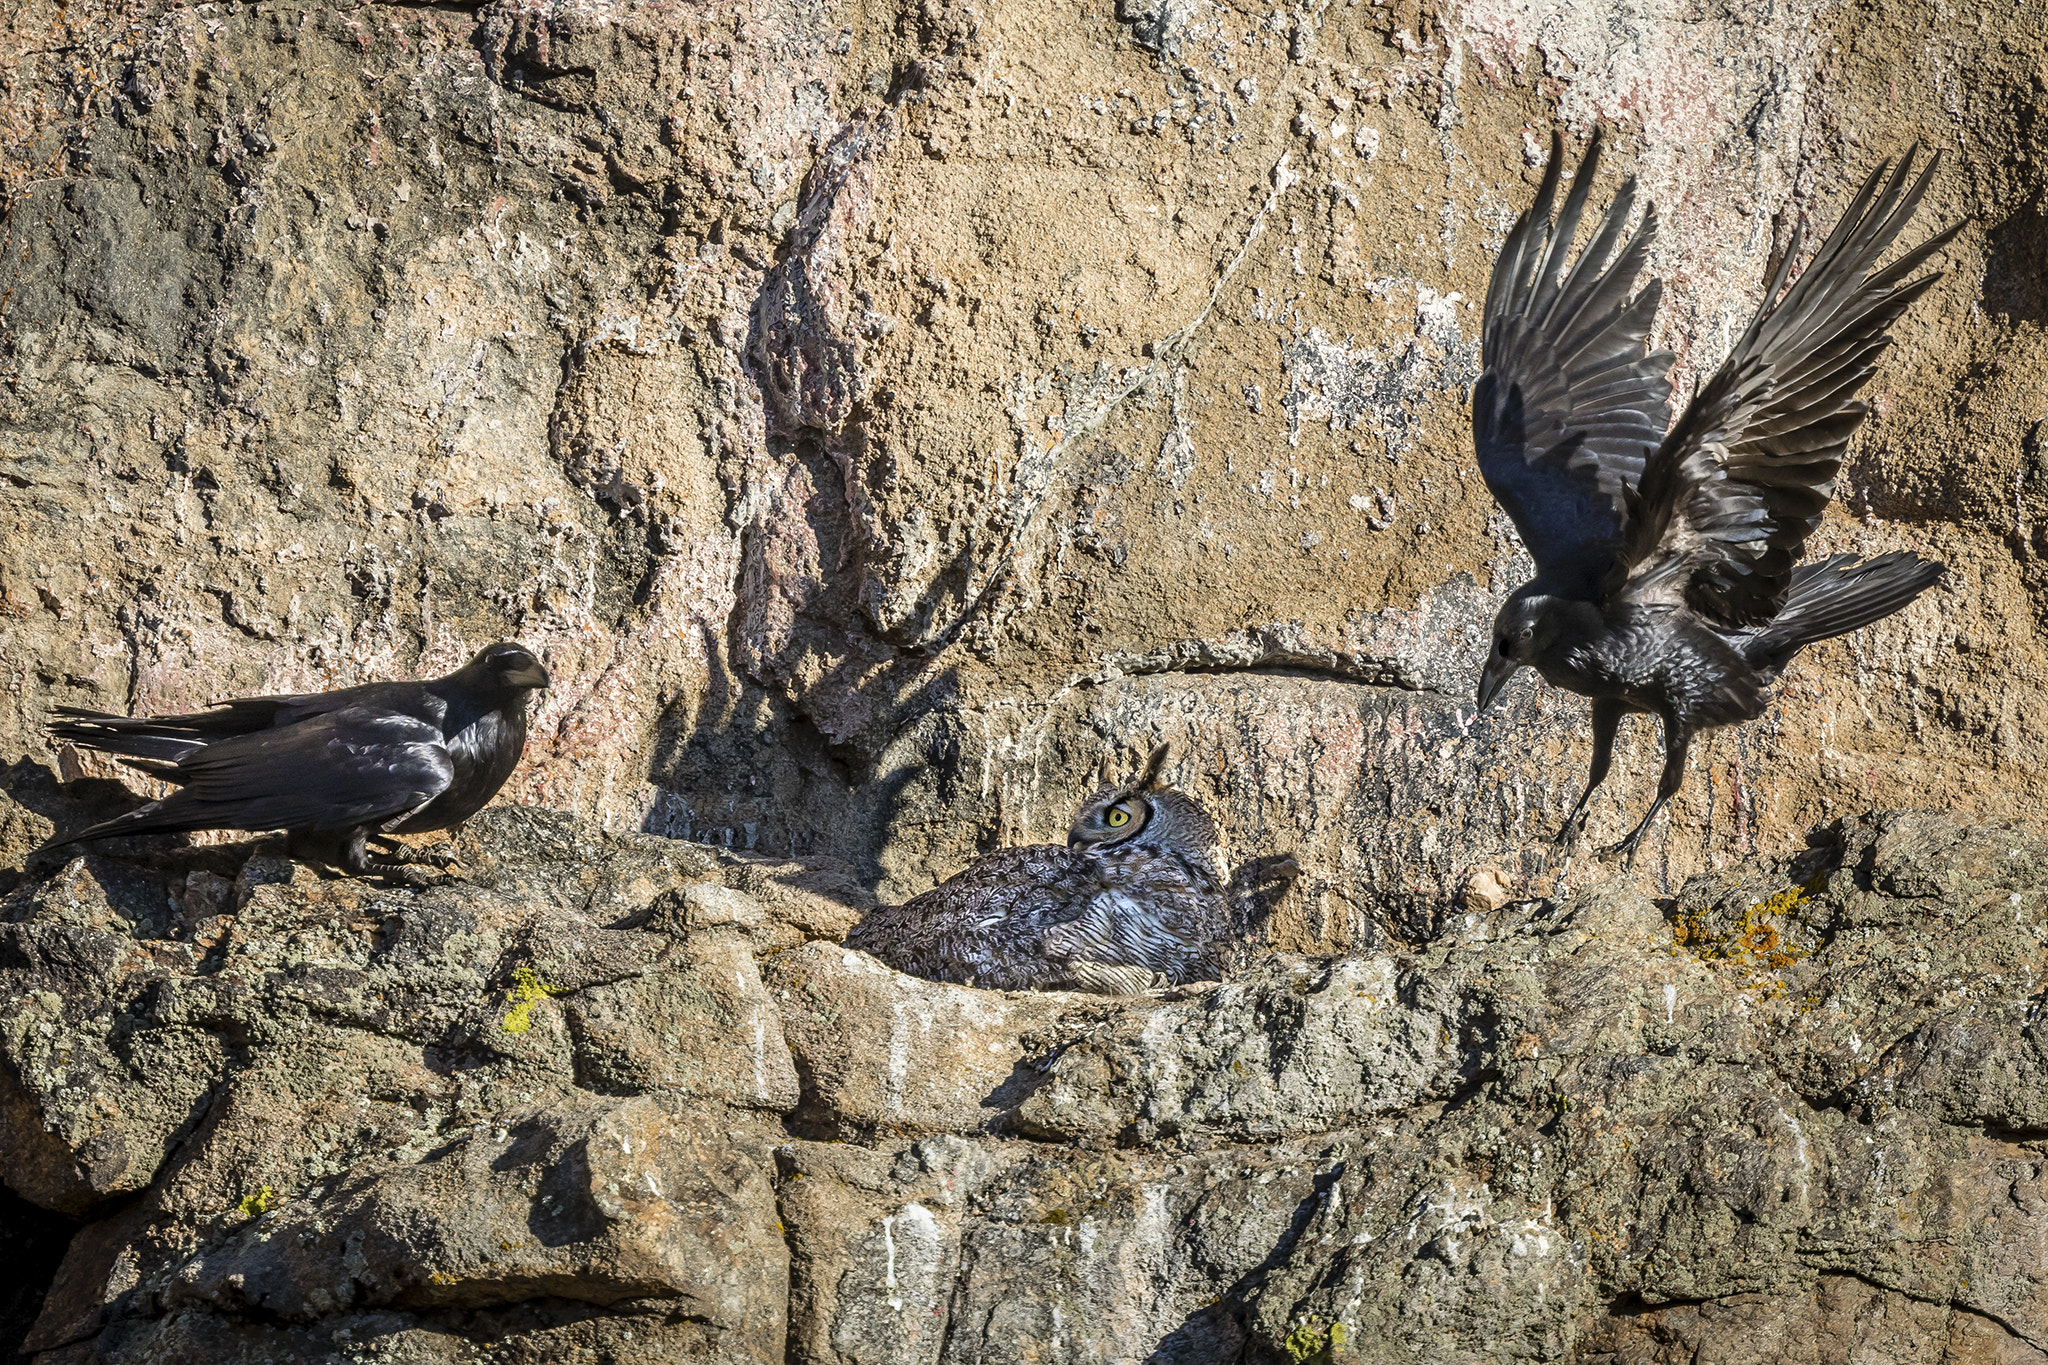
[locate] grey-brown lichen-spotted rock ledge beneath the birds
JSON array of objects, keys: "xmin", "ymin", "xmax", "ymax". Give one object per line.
[{"xmin": 0, "ymin": 794, "xmax": 2048, "ymax": 1365}]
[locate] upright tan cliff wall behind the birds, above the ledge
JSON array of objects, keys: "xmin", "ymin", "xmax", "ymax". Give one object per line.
[{"xmin": 0, "ymin": 0, "xmax": 2048, "ymax": 952}]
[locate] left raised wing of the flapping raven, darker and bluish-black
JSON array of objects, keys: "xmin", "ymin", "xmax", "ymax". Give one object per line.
[{"xmin": 1473, "ymin": 133, "xmax": 1671, "ymax": 596}]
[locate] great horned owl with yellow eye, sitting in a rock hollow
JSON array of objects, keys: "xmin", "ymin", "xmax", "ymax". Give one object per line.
[{"xmin": 846, "ymin": 745, "xmax": 1286, "ymax": 995}]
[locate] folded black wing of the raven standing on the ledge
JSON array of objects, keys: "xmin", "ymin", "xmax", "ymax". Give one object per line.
[{"xmin": 61, "ymin": 706, "xmax": 455, "ymax": 843}]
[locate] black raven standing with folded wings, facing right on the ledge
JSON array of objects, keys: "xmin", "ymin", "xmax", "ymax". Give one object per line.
[{"xmin": 45, "ymin": 645, "xmax": 547, "ymax": 874}]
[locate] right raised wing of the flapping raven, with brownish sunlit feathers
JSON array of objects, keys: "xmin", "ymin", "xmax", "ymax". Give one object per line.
[{"xmin": 1608, "ymin": 151, "xmax": 1962, "ymax": 626}]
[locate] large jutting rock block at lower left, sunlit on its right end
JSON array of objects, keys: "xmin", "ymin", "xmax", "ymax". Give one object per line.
[{"xmin": 164, "ymin": 1097, "xmax": 786, "ymax": 1334}]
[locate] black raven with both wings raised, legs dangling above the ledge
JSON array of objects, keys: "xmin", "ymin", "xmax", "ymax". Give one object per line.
[{"xmin": 1473, "ymin": 133, "xmax": 1962, "ymax": 860}]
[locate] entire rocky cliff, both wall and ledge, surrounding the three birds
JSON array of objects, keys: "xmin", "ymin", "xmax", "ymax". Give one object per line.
[{"xmin": 0, "ymin": 0, "xmax": 2048, "ymax": 1365}]
